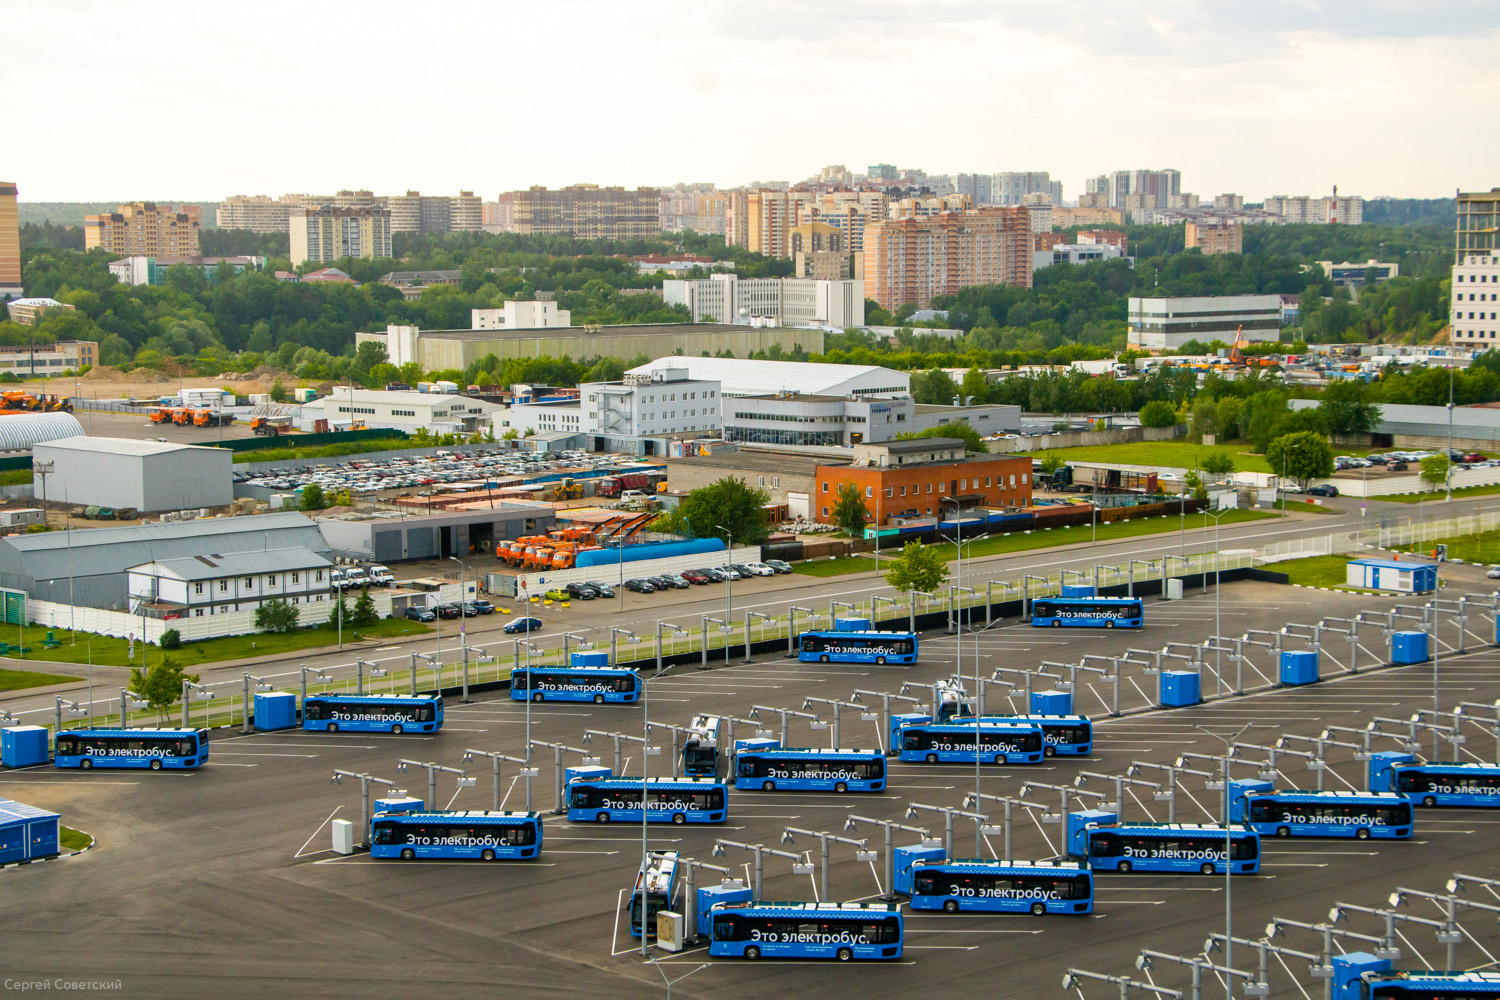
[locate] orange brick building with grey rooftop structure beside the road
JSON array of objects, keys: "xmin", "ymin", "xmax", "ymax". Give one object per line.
[{"xmin": 813, "ymin": 438, "xmax": 1032, "ymax": 526}]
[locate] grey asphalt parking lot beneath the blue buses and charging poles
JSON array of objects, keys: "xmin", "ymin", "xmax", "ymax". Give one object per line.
[{"xmin": 0, "ymin": 583, "xmax": 1500, "ymax": 999}]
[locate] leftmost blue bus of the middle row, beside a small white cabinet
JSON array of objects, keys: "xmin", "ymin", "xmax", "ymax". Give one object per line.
[{"xmin": 371, "ymin": 811, "xmax": 542, "ymax": 861}]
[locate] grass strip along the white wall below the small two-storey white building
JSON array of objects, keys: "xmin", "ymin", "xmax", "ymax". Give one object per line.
[{"xmin": 14, "ymin": 618, "xmax": 432, "ymax": 668}]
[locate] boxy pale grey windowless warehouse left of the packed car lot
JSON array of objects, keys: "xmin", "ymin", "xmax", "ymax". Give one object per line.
[{"xmin": 32, "ymin": 436, "xmax": 234, "ymax": 513}]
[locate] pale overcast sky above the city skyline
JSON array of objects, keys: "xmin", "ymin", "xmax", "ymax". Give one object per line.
[{"xmin": 0, "ymin": 0, "xmax": 1500, "ymax": 201}]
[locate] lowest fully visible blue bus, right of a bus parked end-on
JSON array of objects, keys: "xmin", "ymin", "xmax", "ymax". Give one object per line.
[{"xmin": 708, "ymin": 903, "xmax": 902, "ymax": 963}]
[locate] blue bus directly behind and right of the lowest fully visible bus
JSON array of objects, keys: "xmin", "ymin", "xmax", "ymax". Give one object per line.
[{"xmin": 911, "ymin": 858, "xmax": 1094, "ymax": 916}]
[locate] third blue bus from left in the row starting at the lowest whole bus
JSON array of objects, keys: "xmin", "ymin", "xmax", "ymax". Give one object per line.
[{"xmin": 1085, "ymin": 823, "xmax": 1260, "ymax": 876}]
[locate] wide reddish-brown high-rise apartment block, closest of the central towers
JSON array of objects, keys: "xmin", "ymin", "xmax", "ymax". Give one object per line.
[{"xmin": 864, "ymin": 205, "xmax": 1032, "ymax": 309}]
